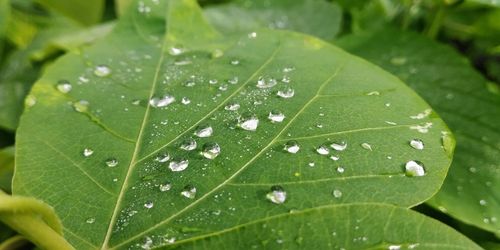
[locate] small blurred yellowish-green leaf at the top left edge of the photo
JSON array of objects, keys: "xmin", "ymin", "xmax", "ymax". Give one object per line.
[{"xmin": 36, "ymin": 0, "xmax": 104, "ymax": 25}]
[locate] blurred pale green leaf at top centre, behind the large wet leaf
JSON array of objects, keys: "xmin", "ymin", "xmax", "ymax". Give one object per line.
[{"xmin": 204, "ymin": 0, "xmax": 342, "ymax": 40}]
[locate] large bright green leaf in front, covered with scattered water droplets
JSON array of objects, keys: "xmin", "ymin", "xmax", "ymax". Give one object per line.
[{"xmin": 13, "ymin": 0, "xmax": 454, "ymax": 249}]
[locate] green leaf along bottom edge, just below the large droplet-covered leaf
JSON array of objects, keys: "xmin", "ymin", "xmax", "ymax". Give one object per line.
[{"xmin": 169, "ymin": 204, "xmax": 481, "ymax": 249}]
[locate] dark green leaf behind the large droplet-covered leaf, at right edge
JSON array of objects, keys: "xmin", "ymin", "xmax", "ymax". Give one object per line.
[{"xmin": 339, "ymin": 29, "xmax": 500, "ymax": 236}]
